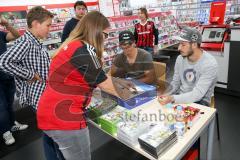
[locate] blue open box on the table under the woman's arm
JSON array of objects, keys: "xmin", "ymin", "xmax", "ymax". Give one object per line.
[{"xmin": 102, "ymin": 80, "xmax": 157, "ymax": 109}]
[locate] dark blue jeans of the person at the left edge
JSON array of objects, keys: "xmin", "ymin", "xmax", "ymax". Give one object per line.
[{"xmin": 0, "ymin": 79, "xmax": 16, "ymax": 135}]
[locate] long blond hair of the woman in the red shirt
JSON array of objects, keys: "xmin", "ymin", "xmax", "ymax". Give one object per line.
[{"xmin": 54, "ymin": 11, "xmax": 110, "ymax": 62}]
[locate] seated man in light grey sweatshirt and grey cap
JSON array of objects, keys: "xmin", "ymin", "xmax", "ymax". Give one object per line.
[{"xmin": 159, "ymin": 27, "xmax": 218, "ymax": 106}]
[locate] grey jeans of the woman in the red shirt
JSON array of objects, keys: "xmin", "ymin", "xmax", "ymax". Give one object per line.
[{"xmin": 44, "ymin": 128, "xmax": 91, "ymax": 160}]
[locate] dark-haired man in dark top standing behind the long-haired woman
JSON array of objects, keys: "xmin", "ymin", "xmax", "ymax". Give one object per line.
[{"xmin": 61, "ymin": 1, "xmax": 88, "ymax": 43}]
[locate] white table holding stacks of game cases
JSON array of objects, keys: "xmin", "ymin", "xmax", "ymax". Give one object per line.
[{"xmin": 90, "ymin": 99, "xmax": 216, "ymax": 160}]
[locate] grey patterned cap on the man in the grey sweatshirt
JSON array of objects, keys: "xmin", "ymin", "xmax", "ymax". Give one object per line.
[{"xmin": 173, "ymin": 27, "xmax": 202, "ymax": 44}]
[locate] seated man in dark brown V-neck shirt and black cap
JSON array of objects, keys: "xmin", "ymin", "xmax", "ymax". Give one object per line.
[{"xmin": 111, "ymin": 31, "xmax": 155, "ymax": 84}]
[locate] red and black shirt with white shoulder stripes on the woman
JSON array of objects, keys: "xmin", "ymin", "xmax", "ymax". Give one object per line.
[{"xmin": 37, "ymin": 40, "xmax": 107, "ymax": 130}]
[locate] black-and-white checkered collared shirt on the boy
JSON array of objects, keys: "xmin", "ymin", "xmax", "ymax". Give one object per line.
[{"xmin": 0, "ymin": 31, "xmax": 50, "ymax": 109}]
